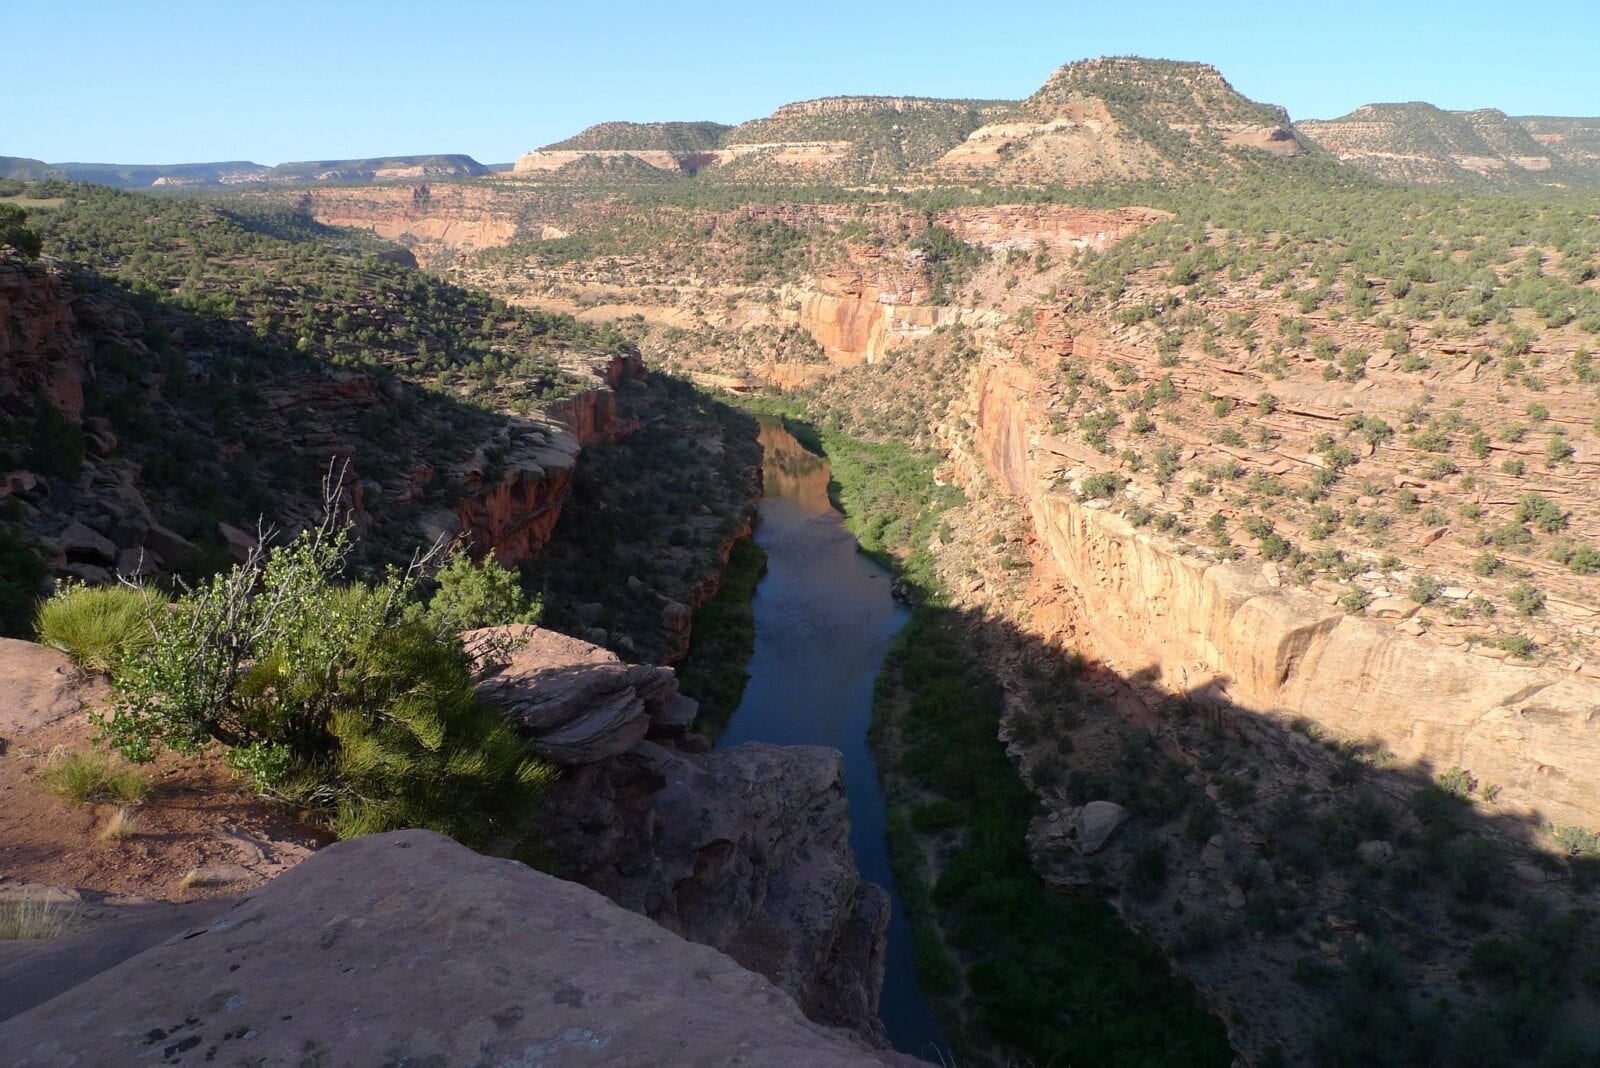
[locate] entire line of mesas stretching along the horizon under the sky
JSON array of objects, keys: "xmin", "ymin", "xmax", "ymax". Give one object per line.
[{"xmin": 12, "ymin": 56, "xmax": 1600, "ymax": 189}]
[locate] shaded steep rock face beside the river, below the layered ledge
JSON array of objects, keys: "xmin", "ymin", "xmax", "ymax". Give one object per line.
[{"xmin": 546, "ymin": 742, "xmax": 890, "ymax": 1042}]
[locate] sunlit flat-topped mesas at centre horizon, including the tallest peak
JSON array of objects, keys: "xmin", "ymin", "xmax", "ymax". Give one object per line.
[{"xmin": 514, "ymin": 58, "xmax": 1307, "ymax": 185}]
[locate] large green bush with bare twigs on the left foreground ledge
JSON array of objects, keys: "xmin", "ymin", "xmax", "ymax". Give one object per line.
[{"xmin": 96, "ymin": 521, "xmax": 552, "ymax": 847}]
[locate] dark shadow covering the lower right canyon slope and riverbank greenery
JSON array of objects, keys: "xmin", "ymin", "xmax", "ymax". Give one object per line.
[{"xmin": 875, "ymin": 585, "xmax": 1600, "ymax": 1065}]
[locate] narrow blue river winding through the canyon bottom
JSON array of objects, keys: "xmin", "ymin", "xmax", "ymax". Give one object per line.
[{"xmin": 717, "ymin": 417, "xmax": 944, "ymax": 1060}]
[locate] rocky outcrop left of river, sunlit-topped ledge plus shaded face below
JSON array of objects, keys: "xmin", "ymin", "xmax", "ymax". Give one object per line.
[{"xmin": 467, "ymin": 627, "xmax": 890, "ymax": 1044}]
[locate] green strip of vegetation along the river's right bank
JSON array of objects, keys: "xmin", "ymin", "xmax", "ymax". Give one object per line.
[{"xmin": 739, "ymin": 391, "xmax": 1232, "ymax": 1065}]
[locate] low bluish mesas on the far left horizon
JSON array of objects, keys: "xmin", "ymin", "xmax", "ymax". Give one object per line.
[{"xmin": 0, "ymin": 153, "xmax": 490, "ymax": 189}]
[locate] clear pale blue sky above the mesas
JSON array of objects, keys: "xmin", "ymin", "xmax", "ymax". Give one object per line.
[{"xmin": 0, "ymin": 0, "xmax": 1600, "ymax": 163}]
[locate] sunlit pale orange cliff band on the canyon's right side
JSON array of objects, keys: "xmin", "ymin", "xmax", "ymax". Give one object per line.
[{"xmin": 966, "ymin": 357, "xmax": 1600, "ymax": 827}]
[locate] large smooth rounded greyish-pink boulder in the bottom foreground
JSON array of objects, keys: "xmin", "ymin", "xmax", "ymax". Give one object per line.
[{"xmin": 0, "ymin": 831, "xmax": 906, "ymax": 1068}]
